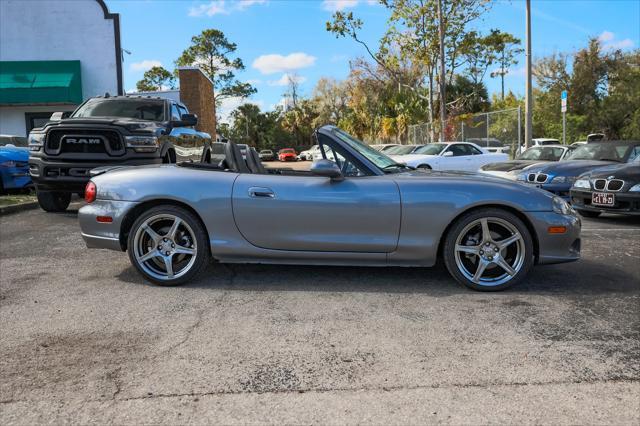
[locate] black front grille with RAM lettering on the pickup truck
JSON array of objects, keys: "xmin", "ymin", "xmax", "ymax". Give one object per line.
[{"xmin": 46, "ymin": 129, "xmax": 125, "ymax": 155}]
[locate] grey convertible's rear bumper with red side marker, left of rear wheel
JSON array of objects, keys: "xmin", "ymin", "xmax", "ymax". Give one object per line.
[{"xmin": 78, "ymin": 200, "xmax": 137, "ymax": 251}]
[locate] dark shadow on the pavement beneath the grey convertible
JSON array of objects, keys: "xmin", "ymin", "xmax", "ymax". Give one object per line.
[{"xmin": 117, "ymin": 260, "xmax": 640, "ymax": 297}]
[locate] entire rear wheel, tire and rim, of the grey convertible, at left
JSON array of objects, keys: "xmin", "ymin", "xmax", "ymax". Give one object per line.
[{"xmin": 127, "ymin": 206, "xmax": 209, "ymax": 286}]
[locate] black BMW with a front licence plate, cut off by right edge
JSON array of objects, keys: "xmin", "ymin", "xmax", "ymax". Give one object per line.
[{"xmin": 571, "ymin": 159, "xmax": 640, "ymax": 217}]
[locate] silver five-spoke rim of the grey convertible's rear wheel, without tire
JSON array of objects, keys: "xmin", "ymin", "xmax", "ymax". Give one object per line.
[{"xmin": 133, "ymin": 214, "xmax": 198, "ymax": 281}]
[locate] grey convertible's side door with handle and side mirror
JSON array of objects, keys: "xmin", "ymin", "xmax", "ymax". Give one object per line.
[{"xmin": 232, "ymin": 143, "xmax": 401, "ymax": 253}]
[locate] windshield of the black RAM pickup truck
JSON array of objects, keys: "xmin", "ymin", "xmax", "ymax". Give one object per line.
[{"xmin": 72, "ymin": 98, "xmax": 164, "ymax": 121}]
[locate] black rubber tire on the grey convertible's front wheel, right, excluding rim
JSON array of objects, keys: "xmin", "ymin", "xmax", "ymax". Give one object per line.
[{"xmin": 442, "ymin": 208, "xmax": 534, "ymax": 291}]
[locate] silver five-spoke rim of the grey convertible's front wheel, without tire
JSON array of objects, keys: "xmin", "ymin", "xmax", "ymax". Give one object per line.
[{"xmin": 455, "ymin": 217, "xmax": 526, "ymax": 286}]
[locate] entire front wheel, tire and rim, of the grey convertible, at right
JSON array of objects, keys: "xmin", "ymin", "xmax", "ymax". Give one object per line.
[{"xmin": 443, "ymin": 208, "xmax": 534, "ymax": 291}]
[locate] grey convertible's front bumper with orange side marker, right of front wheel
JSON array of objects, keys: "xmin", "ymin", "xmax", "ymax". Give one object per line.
[{"xmin": 527, "ymin": 212, "xmax": 582, "ymax": 264}]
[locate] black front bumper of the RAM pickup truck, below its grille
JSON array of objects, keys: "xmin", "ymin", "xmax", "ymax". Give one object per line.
[{"xmin": 29, "ymin": 156, "xmax": 162, "ymax": 192}]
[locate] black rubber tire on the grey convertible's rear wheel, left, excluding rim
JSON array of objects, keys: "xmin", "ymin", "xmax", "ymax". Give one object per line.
[{"xmin": 127, "ymin": 205, "xmax": 210, "ymax": 286}]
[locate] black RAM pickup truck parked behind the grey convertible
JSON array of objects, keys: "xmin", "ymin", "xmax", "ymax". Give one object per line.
[{"xmin": 29, "ymin": 95, "xmax": 211, "ymax": 212}]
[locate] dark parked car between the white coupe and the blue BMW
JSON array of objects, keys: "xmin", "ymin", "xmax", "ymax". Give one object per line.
[{"xmin": 478, "ymin": 145, "xmax": 575, "ymax": 180}]
